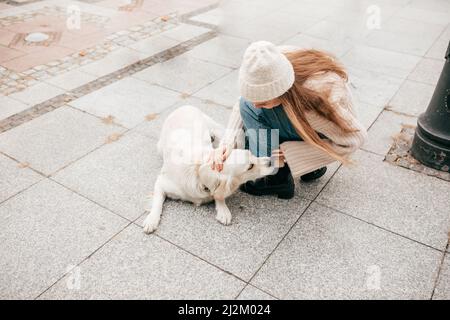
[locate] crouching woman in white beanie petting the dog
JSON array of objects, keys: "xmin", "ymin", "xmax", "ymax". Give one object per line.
[{"xmin": 212, "ymin": 41, "xmax": 367, "ymax": 199}]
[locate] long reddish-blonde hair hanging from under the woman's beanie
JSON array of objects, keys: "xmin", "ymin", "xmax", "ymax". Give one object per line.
[{"xmin": 279, "ymin": 50, "xmax": 358, "ymax": 164}]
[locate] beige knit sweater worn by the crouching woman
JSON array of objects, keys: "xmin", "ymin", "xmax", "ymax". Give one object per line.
[{"xmin": 221, "ymin": 47, "xmax": 367, "ymax": 177}]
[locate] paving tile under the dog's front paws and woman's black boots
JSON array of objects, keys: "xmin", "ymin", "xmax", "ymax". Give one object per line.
[{"xmin": 134, "ymin": 192, "xmax": 309, "ymax": 280}]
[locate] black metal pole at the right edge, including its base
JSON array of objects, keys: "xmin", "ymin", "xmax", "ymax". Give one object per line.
[{"xmin": 411, "ymin": 42, "xmax": 450, "ymax": 172}]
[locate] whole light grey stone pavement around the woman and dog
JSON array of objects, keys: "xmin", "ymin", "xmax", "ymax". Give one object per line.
[{"xmin": 0, "ymin": 0, "xmax": 450, "ymax": 299}]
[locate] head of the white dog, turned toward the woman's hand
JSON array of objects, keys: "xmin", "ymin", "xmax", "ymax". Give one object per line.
[{"xmin": 198, "ymin": 149, "xmax": 274, "ymax": 199}]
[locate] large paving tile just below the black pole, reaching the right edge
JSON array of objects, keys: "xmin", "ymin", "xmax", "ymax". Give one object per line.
[{"xmin": 317, "ymin": 151, "xmax": 450, "ymax": 250}]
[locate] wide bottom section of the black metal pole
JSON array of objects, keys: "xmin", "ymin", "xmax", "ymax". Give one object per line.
[{"xmin": 411, "ymin": 124, "xmax": 450, "ymax": 172}]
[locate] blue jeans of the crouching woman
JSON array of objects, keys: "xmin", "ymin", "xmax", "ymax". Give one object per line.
[{"xmin": 239, "ymin": 98, "xmax": 302, "ymax": 157}]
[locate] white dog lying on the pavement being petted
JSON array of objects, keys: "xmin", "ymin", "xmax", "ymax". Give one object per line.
[{"xmin": 144, "ymin": 106, "xmax": 273, "ymax": 233}]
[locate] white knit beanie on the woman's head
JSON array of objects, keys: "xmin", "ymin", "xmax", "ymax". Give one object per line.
[{"xmin": 239, "ymin": 41, "xmax": 295, "ymax": 102}]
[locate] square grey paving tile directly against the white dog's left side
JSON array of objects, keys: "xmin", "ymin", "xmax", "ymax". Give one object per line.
[{"xmin": 53, "ymin": 133, "xmax": 162, "ymax": 220}]
